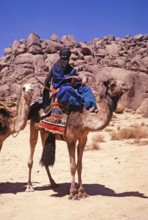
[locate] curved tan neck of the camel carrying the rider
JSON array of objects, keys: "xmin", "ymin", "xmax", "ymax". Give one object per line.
[{"xmin": 85, "ymin": 97, "xmax": 118, "ymax": 131}]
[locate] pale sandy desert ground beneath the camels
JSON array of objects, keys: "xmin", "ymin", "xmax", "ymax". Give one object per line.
[{"xmin": 0, "ymin": 114, "xmax": 148, "ymax": 220}]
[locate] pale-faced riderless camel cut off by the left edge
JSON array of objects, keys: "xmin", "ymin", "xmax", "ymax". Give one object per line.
[{"xmin": 0, "ymin": 84, "xmax": 33, "ymax": 151}]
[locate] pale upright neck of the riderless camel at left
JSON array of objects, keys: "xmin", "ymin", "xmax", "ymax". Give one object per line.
[{"xmin": 12, "ymin": 95, "xmax": 31, "ymax": 132}]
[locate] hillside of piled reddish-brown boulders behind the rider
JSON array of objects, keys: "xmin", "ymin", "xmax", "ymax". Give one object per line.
[{"xmin": 0, "ymin": 33, "xmax": 148, "ymax": 116}]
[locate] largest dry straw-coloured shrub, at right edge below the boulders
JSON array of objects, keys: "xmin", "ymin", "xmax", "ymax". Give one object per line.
[{"xmin": 111, "ymin": 125, "xmax": 148, "ymax": 140}]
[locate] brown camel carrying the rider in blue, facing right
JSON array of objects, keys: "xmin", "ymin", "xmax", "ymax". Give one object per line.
[{"xmin": 26, "ymin": 78, "xmax": 128, "ymax": 199}]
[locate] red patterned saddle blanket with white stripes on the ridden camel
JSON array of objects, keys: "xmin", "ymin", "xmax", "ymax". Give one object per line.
[{"xmin": 39, "ymin": 103, "xmax": 68, "ymax": 134}]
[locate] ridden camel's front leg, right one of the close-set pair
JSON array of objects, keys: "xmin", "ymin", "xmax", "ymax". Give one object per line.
[{"xmin": 77, "ymin": 137, "xmax": 88, "ymax": 198}]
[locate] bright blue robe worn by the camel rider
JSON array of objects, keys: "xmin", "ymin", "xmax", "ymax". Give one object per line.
[{"xmin": 52, "ymin": 60, "xmax": 97, "ymax": 109}]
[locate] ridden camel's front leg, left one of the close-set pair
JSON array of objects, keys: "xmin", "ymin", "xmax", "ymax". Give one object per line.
[{"xmin": 67, "ymin": 142, "xmax": 78, "ymax": 199}]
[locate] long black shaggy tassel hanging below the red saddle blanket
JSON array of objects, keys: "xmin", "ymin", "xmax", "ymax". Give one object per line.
[{"xmin": 40, "ymin": 134, "xmax": 56, "ymax": 166}]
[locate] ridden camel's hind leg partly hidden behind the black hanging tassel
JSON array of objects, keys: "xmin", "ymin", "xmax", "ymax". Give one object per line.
[{"xmin": 41, "ymin": 131, "xmax": 58, "ymax": 187}]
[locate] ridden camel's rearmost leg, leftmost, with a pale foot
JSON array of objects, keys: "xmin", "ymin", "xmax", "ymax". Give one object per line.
[{"xmin": 26, "ymin": 121, "xmax": 38, "ymax": 192}]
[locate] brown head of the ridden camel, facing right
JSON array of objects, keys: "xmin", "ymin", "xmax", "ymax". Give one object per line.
[{"xmin": 103, "ymin": 78, "xmax": 129, "ymax": 97}]
